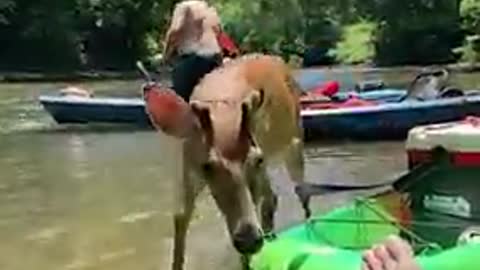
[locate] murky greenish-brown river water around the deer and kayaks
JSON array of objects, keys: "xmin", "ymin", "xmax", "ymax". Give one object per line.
[{"xmin": 0, "ymin": 69, "xmax": 480, "ymax": 270}]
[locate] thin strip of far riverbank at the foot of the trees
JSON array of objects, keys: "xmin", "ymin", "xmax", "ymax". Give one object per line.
[{"xmin": 0, "ymin": 63, "xmax": 480, "ymax": 83}]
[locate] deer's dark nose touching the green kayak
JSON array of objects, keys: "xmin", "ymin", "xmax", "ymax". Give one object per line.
[{"xmin": 233, "ymin": 224, "xmax": 263, "ymax": 254}]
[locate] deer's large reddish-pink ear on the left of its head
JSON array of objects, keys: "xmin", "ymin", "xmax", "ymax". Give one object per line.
[{"xmin": 143, "ymin": 83, "xmax": 194, "ymax": 138}]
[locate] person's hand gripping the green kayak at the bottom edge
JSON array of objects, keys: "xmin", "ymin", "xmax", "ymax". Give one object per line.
[{"xmin": 362, "ymin": 235, "xmax": 420, "ymax": 270}]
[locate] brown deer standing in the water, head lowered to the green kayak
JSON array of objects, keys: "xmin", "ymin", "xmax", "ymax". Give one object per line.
[{"xmin": 143, "ymin": 54, "xmax": 310, "ymax": 270}]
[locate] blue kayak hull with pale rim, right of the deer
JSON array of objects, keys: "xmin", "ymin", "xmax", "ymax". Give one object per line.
[{"xmin": 301, "ymin": 95, "xmax": 480, "ymax": 140}]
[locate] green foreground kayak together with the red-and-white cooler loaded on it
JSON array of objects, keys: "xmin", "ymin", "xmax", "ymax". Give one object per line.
[{"xmin": 251, "ymin": 116, "xmax": 480, "ymax": 270}]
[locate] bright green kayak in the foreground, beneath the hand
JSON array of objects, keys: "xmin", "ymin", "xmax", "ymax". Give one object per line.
[{"xmin": 251, "ymin": 192, "xmax": 480, "ymax": 270}]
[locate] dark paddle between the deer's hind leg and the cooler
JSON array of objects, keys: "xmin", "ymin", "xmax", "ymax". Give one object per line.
[{"xmin": 295, "ymin": 159, "xmax": 439, "ymax": 198}]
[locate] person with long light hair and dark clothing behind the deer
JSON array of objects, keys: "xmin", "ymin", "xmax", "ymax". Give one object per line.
[{"xmin": 163, "ymin": 0, "xmax": 238, "ymax": 102}]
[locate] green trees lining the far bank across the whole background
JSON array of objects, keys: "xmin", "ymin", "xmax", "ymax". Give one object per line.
[{"xmin": 0, "ymin": 0, "xmax": 480, "ymax": 70}]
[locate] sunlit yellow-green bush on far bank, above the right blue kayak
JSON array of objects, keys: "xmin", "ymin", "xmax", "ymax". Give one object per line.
[{"xmin": 333, "ymin": 21, "xmax": 376, "ymax": 64}]
